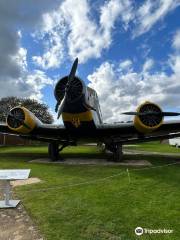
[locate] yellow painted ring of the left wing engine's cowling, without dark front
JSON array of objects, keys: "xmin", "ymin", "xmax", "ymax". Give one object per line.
[{"xmin": 7, "ymin": 107, "xmax": 37, "ymax": 134}]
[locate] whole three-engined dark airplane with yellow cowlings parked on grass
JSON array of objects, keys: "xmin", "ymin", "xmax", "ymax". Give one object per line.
[{"xmin": 0, "ymin": 58, "xmax": 180, "ymax": 161}]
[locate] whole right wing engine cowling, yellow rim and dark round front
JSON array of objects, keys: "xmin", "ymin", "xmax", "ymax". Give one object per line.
[{"xmin": 134, "ymin": 102, "xmax": 163, "ymax": 133}]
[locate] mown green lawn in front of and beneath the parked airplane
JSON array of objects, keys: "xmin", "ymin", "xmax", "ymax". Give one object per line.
[{"xmin": 0, "ymin": 146, "xmax": 180, "ymax": 240}]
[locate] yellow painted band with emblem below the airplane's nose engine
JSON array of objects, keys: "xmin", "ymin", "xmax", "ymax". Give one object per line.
[{"xmin": 62, "ymin": 111, "xmax": 93, "ymax": 128}]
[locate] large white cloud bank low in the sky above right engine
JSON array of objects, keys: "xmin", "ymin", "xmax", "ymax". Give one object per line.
[{"xmin": 88, "ymin": 56, "xmax": 180, "ymax": 122}]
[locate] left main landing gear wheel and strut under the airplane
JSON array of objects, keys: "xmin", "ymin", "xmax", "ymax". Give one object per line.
[{"xmin": 48, "ymin": 142, "xmax": 68, "ymax": 162}]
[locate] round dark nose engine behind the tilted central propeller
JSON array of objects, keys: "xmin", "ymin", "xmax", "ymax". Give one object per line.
[{"xmin": 54, "ymin": 76, "xmax": 85, "ymax": 103}]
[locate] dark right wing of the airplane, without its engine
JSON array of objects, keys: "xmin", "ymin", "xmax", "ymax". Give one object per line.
[{"xmin": 97, "ymin": 121, "xmax": 180, "ymax": 144}]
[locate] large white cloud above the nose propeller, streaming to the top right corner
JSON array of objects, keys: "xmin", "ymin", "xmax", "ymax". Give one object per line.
[{"xmin": 32, "ymin": 0, "xmax": 180, "ymax": 69}]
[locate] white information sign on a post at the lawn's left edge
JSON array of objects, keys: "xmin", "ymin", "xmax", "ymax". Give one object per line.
[{"xmin": 0, "ymin": 169, "xmax": 31, "ymax": 208}]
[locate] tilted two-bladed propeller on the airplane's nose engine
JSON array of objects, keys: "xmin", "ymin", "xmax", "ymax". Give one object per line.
[{"xmin": 56, "ymin": 58, "xmax": 78, "ymax": 119}]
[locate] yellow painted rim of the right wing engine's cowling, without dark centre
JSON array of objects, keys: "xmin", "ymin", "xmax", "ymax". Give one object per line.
[{"xmin": 134, "ymin": 102, "xmax": 163, "ymax": 133}]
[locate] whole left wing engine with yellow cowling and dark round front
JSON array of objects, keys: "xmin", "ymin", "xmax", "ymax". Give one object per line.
[{"xmin": 6, "ymin": 107, "xmax": 41, "ymax": 134}]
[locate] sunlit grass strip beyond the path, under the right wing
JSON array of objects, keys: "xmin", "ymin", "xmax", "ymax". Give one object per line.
[{"xmin": 125, "ymin": 141, "xmax": 180, "ymax": 154}]
